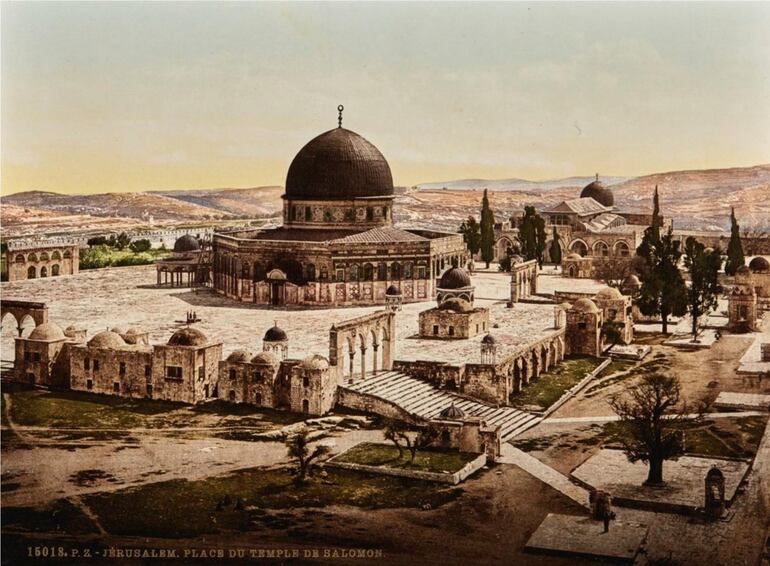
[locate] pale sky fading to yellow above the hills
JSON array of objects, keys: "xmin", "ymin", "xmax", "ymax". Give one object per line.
[{"xmin": 0, "ymin": 2, "xmax": 770, "ymax": 194}]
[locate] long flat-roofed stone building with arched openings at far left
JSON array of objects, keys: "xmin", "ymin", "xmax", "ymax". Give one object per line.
[{"xmin": 2, "ymin": 238, "xmax": 80, "ymax": 281}]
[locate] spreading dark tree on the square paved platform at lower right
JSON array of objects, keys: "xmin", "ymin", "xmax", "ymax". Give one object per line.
[{"xmin": 609, "ymin": 373, "xmax": 703, "ymax": 486}]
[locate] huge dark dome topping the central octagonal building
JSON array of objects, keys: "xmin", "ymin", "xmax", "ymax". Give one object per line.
[{"xmin": 285, "ymin": 128, "xmax": 393, "ymax": 200}]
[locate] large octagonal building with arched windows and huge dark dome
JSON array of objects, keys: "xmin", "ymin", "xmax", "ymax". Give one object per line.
[{"xmin": 207, "ymin": 111, "xmax": 467, "ymax": 306}]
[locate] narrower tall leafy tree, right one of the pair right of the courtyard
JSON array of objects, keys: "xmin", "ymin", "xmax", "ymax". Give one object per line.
[{"xmin": 684, "ymin": 236, "xmax": 729, "ymax": 339}]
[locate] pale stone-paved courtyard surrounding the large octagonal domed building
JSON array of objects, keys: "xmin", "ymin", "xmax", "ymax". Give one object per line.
[{"xmin": 1, "ymin": 266, "xmax": 602, "ymax": 367}]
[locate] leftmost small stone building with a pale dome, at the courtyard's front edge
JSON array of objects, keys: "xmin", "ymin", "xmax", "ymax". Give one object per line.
[{"xmin": 12, "ymin": 322, "xmax": 73, "ymax": 387}]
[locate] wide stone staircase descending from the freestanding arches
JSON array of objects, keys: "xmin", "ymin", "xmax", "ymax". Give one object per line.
[{"xmin": 342, "ymin": 371, "xmax": 542, "ymax": 442}]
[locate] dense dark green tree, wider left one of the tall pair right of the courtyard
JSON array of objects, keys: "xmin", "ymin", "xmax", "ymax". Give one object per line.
[{"xmin": 637, "ymin": 225, "xmax": 687, "ymax": 334}]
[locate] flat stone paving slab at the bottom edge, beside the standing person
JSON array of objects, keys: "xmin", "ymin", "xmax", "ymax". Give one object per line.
[{"xmin": 526, "ymin": 513, "xmax": 648, "ymax": 563}]
